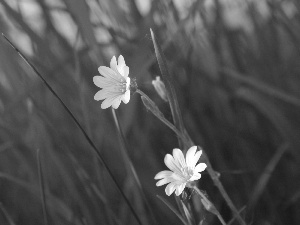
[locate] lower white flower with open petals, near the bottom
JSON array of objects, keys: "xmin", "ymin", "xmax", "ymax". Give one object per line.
[{"xmin": 154, "ymin": 146, "xmax": 206, "ymax": 196}]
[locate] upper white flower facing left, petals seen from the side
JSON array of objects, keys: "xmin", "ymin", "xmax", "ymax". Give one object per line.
[{"xmin": 93, "ymin": 55, "xmax": 130, "ymax": 109}]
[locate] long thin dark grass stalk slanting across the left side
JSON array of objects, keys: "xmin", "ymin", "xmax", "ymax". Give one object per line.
[{"xmin": 2, "ymin": 33, "xmax": 142, "ymax": 225}]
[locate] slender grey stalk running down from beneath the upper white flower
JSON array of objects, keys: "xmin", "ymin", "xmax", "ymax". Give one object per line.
[{"xmin": 111, "ymin": 108, "xmax": 157, "ymax": 224}]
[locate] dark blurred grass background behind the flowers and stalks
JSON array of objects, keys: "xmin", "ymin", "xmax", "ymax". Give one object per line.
[{"xmin": 0, "ymin": 0, "xmax": 300, "ymax": 225}]
